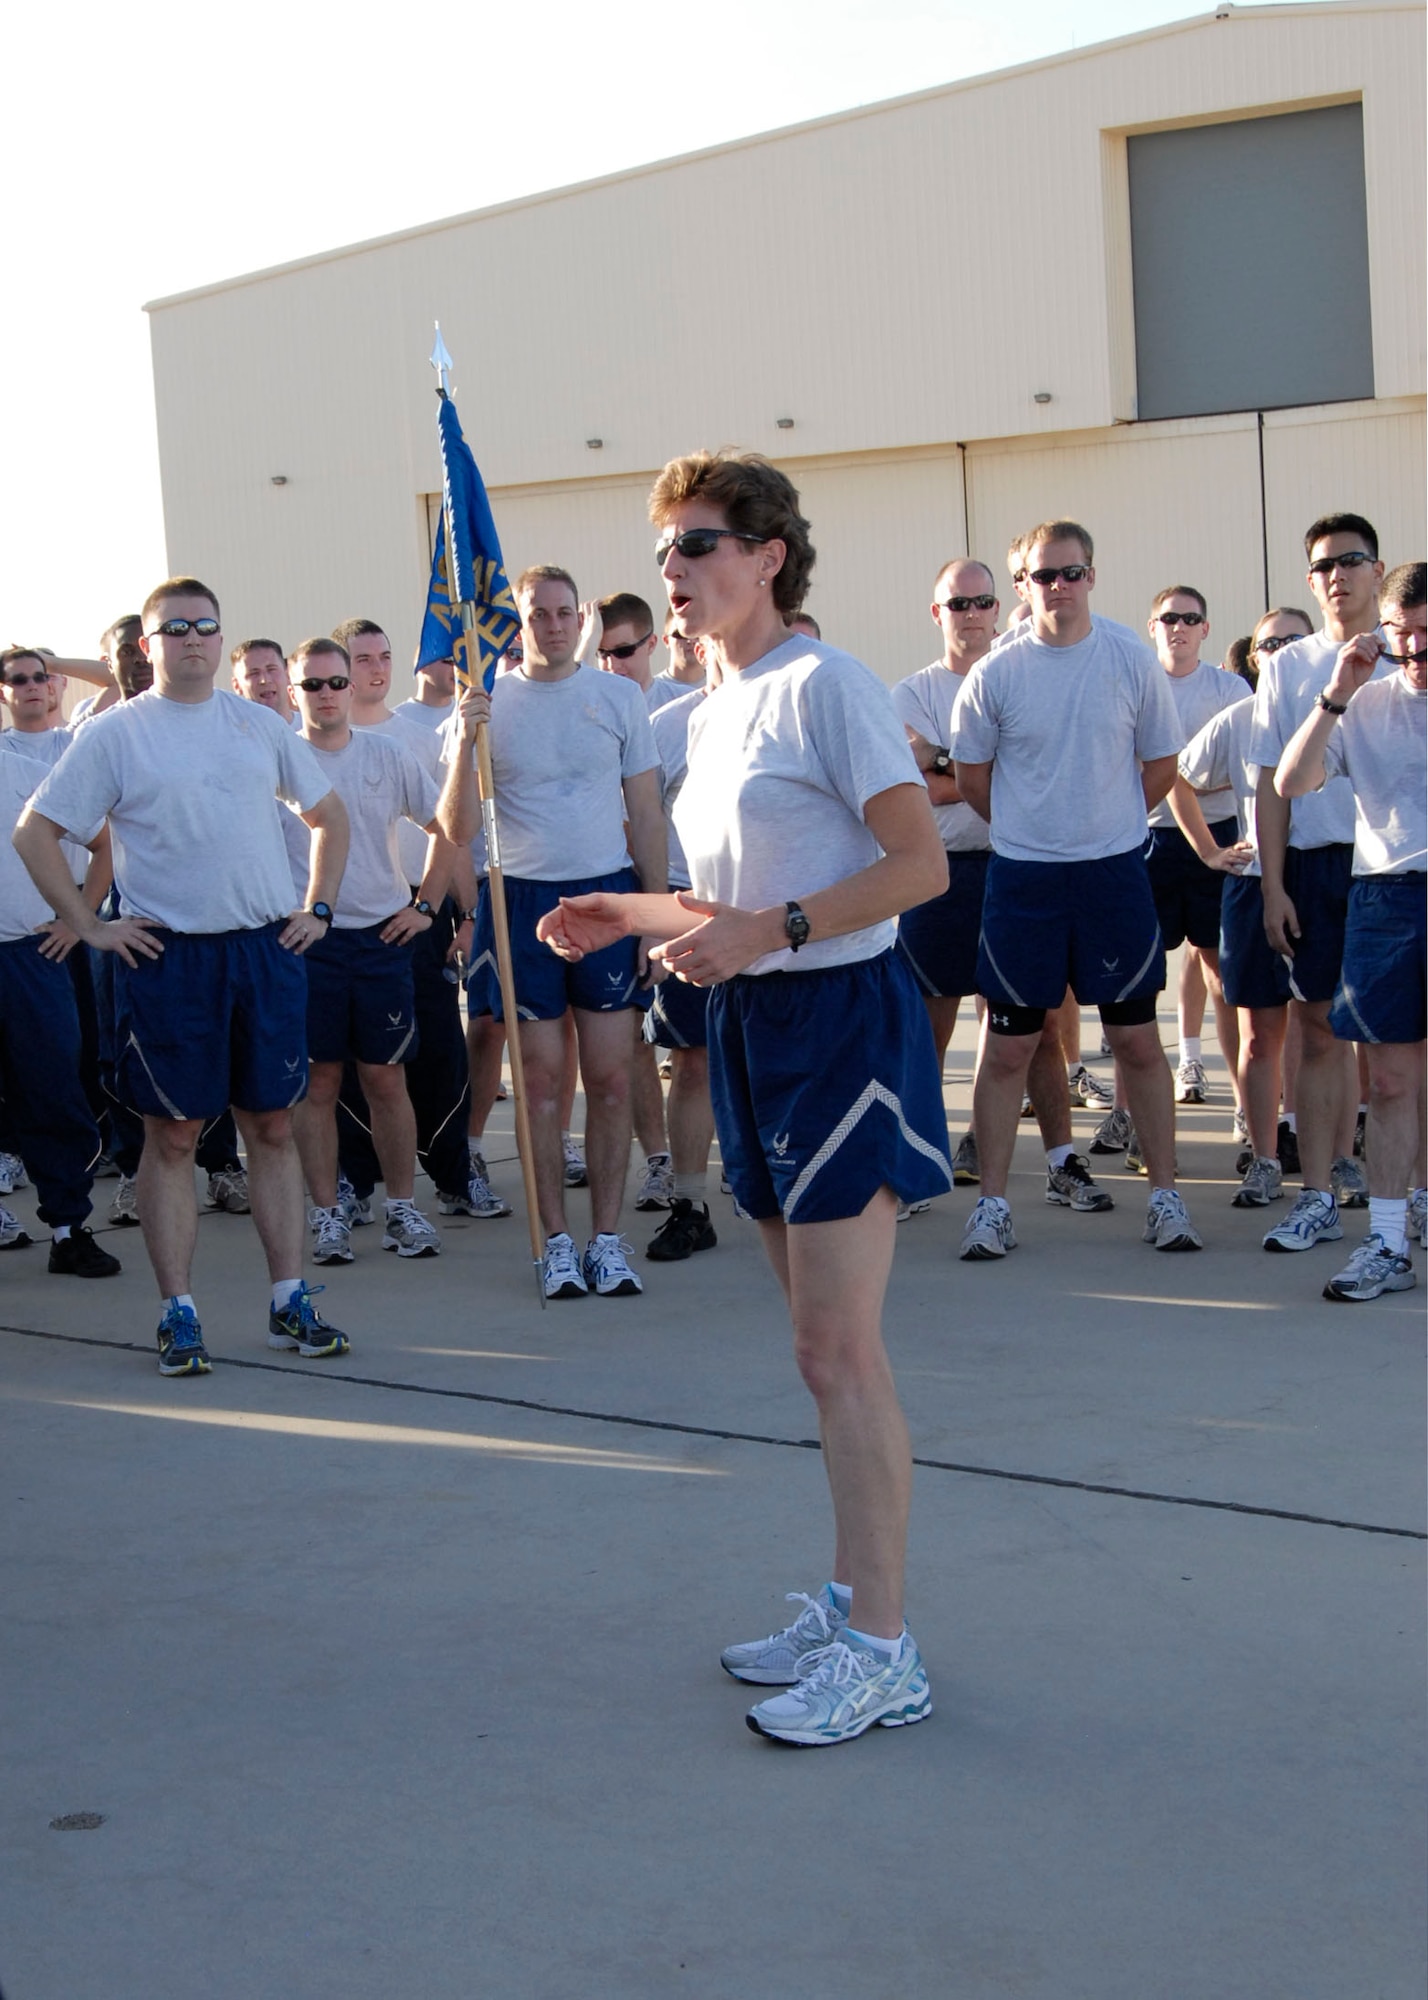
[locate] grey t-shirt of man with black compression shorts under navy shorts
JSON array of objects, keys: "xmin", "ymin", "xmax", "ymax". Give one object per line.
[{"xmin": 952, "ymin": 622, "xmax": 1184, "ymax": 862}]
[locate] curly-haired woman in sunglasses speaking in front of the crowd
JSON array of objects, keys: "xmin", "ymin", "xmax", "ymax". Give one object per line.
[{"xmin": 540, "ymin": 452, "xmax": 952, "ymax": 1744}]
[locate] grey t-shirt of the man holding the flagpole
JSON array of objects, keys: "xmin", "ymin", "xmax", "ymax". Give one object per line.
[{"xmin": 442, "ymin": 666, "xmax": 660, "ymax": 882}]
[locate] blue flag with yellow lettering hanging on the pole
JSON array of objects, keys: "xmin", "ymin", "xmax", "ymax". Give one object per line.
[{"xmin": 416, "ymin": 396, "xmax": 520, "ymax": 694}]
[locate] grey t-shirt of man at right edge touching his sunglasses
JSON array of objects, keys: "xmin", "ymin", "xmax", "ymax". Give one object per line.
[{"xmin": 1296, "ymin": 668, "xmax": 1428, "ymax": 874}]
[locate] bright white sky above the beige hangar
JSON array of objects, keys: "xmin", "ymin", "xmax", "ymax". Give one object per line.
[{"xmin": 0, "ymin": 0, "xmax": 1296, "ymax": 654}]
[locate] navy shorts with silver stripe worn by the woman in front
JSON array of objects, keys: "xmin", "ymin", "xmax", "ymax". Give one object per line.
[{"xmin": 708, "ymin": 952, "xmax": 952, "ymax": 1222}]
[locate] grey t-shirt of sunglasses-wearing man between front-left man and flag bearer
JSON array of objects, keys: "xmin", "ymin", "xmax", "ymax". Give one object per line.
[{"xmin": 290, "ymin": 728, "xmax": 436, "ymax": 930}]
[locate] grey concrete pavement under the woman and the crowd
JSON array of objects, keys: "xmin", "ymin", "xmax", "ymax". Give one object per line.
[{"xmin": 0, "ymin": 1000, "xmax": 1424, "ymax": 2000}]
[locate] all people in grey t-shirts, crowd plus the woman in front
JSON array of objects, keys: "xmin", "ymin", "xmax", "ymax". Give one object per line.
[{"xmin": 0, "ymin": 452, "xmax": 1428, "ymax": 1744}]
